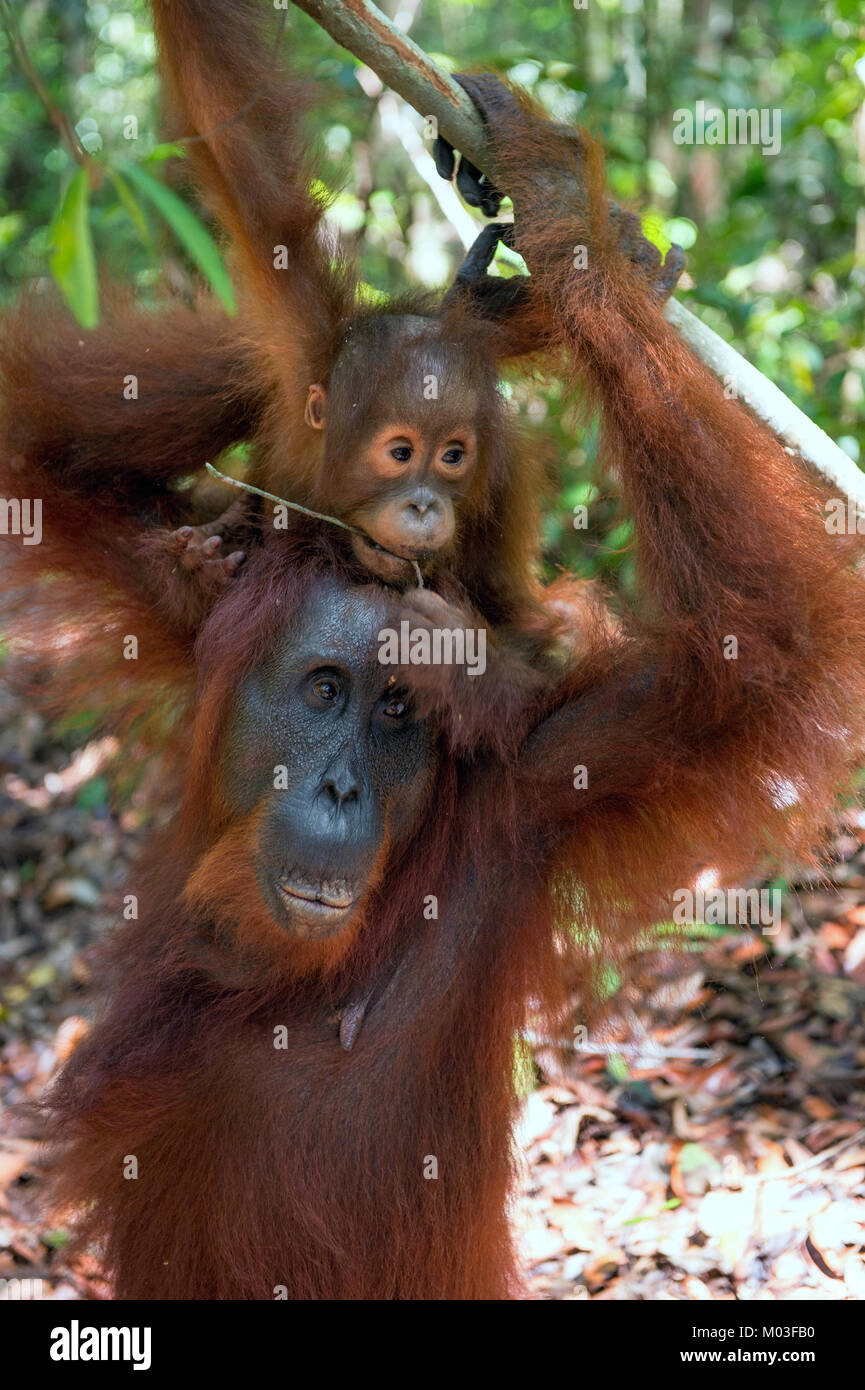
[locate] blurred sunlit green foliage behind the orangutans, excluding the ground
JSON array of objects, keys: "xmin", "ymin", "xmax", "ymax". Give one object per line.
[{"xmin": 0, "ymin": 0, "xmax": 865, "ymax": 585}]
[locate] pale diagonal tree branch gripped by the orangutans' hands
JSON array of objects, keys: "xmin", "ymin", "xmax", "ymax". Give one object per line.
[{"xmin": 287, "ymin": 0, "xmax": 865, "ymax": 513}]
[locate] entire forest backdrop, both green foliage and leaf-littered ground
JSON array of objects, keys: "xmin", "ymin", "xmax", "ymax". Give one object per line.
[{"xmin": 0, "ymin": 0, "xmax": 865, "ymax": 1301}]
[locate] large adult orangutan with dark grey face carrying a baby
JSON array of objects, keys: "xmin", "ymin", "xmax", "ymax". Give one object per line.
[{"xmin": 0, "ymin": 43, "xmax": 865, "ymax": 1298}]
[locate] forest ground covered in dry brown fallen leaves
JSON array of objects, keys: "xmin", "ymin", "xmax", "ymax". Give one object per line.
[{"xmin": 0, "ymin": 664, "xmax": 865, "ymax": 1300}]
